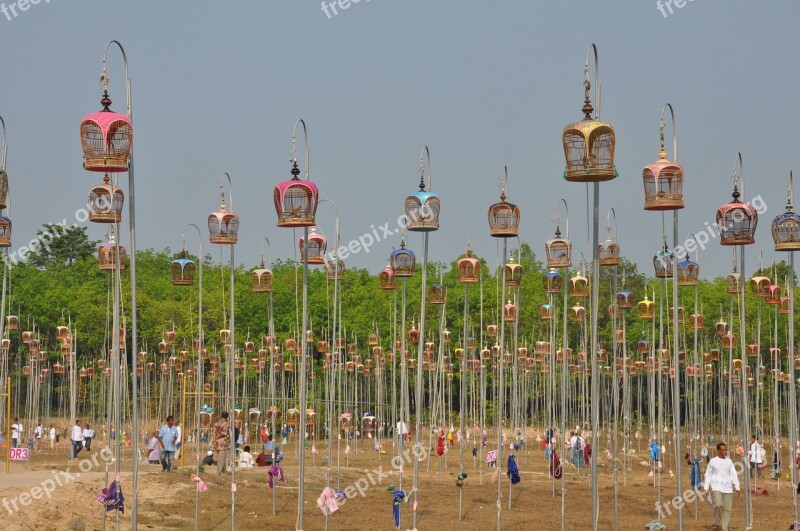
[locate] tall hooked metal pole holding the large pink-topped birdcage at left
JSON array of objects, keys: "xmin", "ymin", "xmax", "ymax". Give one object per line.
[{"xmin": 103, "ymin": 40, "xmax": 139, "ymax": 529}]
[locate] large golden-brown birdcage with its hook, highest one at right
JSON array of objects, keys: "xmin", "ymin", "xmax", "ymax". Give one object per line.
[{"xmin": 562, "ymin": 45, "xmax": 617, "ymax": 183}]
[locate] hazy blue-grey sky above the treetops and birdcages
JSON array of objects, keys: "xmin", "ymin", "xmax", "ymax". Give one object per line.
[{"xmin": 0, "ymin": 0, "xmax": 800, "ymax": 276}]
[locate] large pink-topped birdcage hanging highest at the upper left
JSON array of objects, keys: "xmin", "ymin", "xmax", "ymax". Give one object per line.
[{"xmin": 80, "ymin": 90, "xmax": 133, "ymax": 173}]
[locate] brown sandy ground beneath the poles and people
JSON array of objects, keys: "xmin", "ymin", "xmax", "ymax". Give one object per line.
[{"xmin": 0, "ymin": 436, "xmax": 792, "ymax": 531}]
